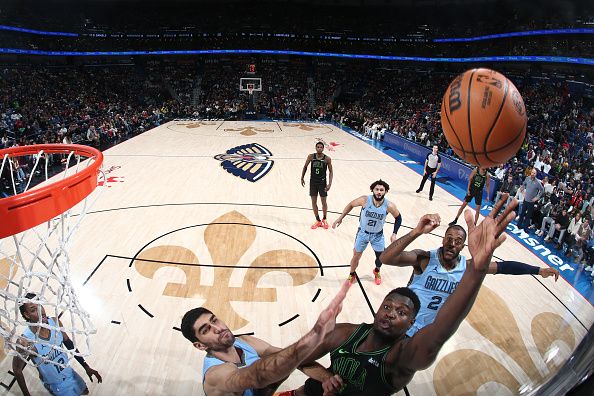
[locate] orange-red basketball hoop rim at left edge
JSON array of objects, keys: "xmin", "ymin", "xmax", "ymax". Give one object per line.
[{"xmin": 0, "ymin": 144, "xmax": 103, "ymax": 239}]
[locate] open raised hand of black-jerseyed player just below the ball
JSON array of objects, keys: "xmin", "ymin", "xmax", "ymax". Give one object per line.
[{"xmin": 464, "ymin": 193, "xmax": 518, "ymax": 272}]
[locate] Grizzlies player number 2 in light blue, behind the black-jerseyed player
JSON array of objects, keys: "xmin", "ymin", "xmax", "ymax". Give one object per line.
[{"xmin": 380, "ymin": 194, "xmax": 559, "ymax": 336}]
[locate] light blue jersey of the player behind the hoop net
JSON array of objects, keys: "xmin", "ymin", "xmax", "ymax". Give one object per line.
[{"xmin": 23, "ymin": 318, "xmax": 74, "ymax": 385}]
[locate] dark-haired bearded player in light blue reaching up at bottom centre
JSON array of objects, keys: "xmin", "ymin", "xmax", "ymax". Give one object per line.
[{"xmin": 180, "ymin": 281, "xmax": 351, "ymax": 396}]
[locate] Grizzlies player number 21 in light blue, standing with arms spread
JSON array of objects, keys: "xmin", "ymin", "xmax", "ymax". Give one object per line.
[{"xmin": 332, "ymin": 179, "xmax": 402, "ymax": 285}]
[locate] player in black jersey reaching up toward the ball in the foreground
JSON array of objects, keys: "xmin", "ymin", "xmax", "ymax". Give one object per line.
[{"xmin": 296, "ymin": 197, "xmax": 518, "ymax": 396}]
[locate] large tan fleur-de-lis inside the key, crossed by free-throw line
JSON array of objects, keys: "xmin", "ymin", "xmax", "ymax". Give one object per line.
[{"xmin": 133, "ymin": 211, "xmax": 319, "ymax": 330}]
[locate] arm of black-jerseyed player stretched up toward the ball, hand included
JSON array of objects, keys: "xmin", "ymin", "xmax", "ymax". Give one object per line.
[{"xmin": 397, "ymin": 194, "xmax": 518, "ymax": 371}]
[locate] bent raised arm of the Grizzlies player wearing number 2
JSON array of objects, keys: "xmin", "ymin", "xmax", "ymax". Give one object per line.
[{"xmin": 380, "ymin": 214, "xmax": 441, "ymax": 267}]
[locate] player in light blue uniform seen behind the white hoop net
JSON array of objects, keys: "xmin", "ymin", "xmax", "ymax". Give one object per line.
[{"xmin": 12, "ymin": 293, "xmax": 103, "ymax": 396}]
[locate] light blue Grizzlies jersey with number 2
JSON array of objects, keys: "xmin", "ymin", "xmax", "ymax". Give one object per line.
[{"xmin": 406, "ymin": 249, "xmax": 466, "ymax": 337}]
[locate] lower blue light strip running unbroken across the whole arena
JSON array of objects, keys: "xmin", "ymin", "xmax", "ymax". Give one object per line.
[{"xmin": 0, "ymin": 48, "xmax": 594, "ymax": 66}]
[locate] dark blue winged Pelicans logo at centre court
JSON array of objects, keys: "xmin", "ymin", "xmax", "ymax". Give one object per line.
[{"xmin": 214, "ymin": 143, "xmax": 274, "ymax": 183}]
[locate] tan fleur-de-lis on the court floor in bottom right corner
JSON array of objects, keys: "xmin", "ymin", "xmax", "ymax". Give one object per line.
[{"xmin": 433, "ymin": 285, "xmax": 575, "ymax": 396}]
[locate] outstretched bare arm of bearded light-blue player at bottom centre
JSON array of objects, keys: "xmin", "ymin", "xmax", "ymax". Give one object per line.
[{"xmin": 205, "ymin": 281, "xmax": 350, "ymax": 392}]
